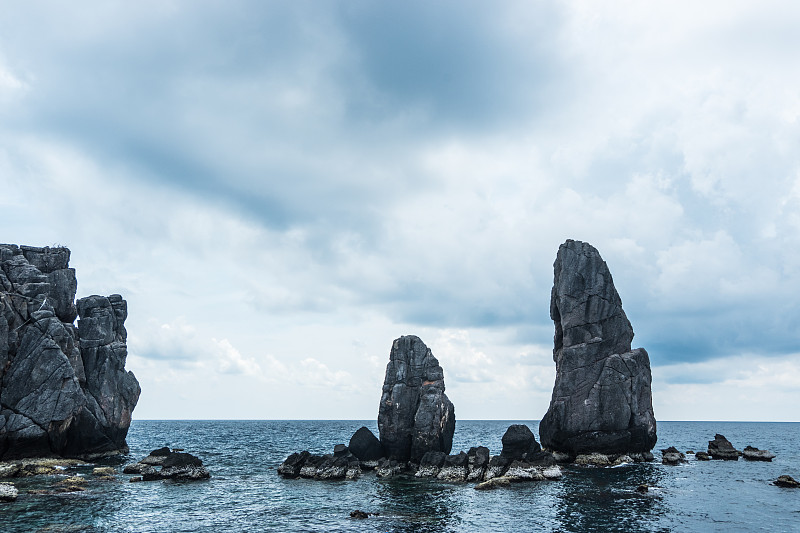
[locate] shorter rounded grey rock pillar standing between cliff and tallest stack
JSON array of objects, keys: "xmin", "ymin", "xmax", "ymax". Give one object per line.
[{"xmin": 378, "ymin": 335, "xmax": 456, "ymax": 462}]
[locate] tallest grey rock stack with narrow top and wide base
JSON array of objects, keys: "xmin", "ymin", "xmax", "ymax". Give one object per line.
[{"xmin": 539, "ymin": 240, "xmax": 656, "ymax": 455}]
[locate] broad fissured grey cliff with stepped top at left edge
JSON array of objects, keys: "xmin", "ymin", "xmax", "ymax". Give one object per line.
[{"xmin": 0, "ymin": 244, "xmax": 140, "ymax": 458}]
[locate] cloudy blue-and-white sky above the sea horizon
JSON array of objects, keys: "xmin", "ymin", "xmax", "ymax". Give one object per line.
[{"xmin": 0, "ymin": 0, "xmax": 800, "ymax": 421}]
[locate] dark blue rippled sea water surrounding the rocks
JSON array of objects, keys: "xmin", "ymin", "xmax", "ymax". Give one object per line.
[{"xmin": 0, "ymin": 420, "xmax": 800, "ymax": 533}]
